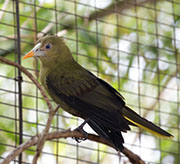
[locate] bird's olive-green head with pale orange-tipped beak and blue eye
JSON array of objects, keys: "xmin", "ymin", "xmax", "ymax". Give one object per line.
[{"xmin": 23, "ymin": 35, "xmax": 73, "ymax": 64}]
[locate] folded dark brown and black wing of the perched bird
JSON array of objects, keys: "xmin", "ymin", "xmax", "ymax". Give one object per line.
[{"xmin": 46, "ymin": 72, "xmax": 130, "ymax": 131}]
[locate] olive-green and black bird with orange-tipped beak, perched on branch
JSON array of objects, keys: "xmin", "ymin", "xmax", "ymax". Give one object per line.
[{"xmin": 23, "ymin": 35, "xmax": 173, "ymax": 151}]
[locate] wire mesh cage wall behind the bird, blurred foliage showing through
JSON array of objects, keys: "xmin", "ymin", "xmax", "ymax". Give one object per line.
[{"xmin": 0, "ymin": 0, "xmax": 180, "ymax": 164}]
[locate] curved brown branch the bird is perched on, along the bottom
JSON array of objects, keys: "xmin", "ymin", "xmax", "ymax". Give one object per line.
[{"xmin": 1, "ymin": 130, "xmax": 145, "ymax": 164}]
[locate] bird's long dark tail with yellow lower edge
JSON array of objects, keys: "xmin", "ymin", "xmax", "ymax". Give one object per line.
[{"xmin": 122, "ymin": 106, "xmax": 173, "ymax": 137}]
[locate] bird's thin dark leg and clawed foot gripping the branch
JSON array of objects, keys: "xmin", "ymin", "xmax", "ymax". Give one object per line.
[{"xmin": 73, "ymin": 120, "xmax": 88, "ymax": 143}]
